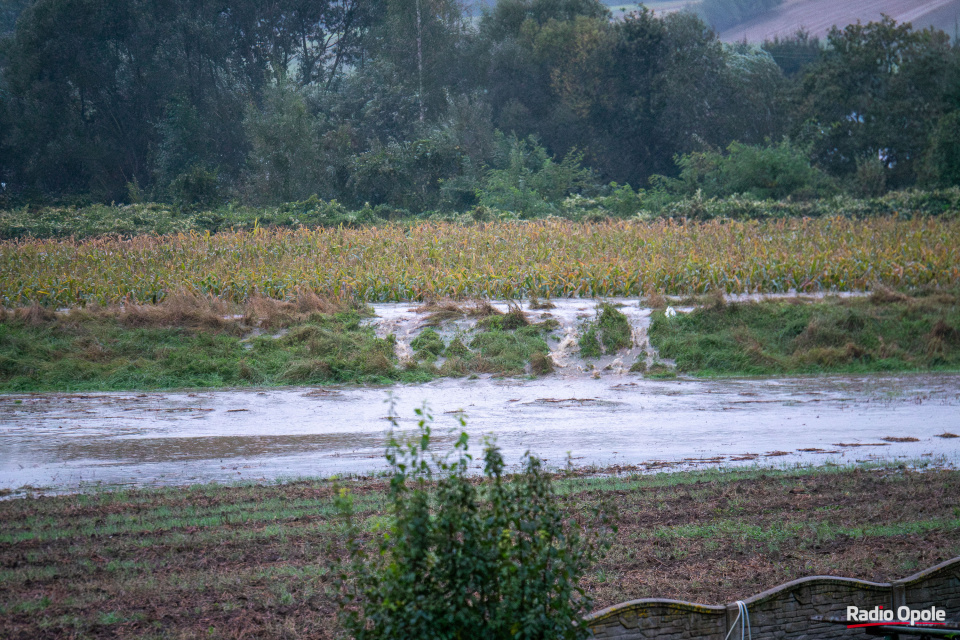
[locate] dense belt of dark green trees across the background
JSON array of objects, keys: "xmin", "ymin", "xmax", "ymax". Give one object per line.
[{"xmin": 0, "ymin": 0, "xmax": 960, "ymax": 210}]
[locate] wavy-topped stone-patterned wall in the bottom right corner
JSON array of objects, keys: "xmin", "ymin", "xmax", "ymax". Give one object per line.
[{"xmin": 587, "ymin": 558, "xmax": 960, "ymax": 640}]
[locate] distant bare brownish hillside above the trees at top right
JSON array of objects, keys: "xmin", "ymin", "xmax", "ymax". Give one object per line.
[{"xmin": 720, "ymin": 0, "xmax": 960, "ymax": 42}]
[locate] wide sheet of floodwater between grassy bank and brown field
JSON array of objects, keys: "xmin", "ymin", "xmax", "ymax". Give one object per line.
[{"xmin": 0, "ymin": 374, "xmax": 960, "ymax": 495}]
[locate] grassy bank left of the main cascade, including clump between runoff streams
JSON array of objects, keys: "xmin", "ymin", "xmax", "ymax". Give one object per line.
[{"xmin": 0, "ymin": 291, "xmax": 568, "ymax": 392}]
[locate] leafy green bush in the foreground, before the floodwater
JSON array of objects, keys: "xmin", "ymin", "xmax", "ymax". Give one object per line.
[{"xmin": 337, "ymin": 410, "xmax": 610, "ymax": 640}]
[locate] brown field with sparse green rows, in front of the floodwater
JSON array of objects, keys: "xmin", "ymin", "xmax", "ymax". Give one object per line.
[{"xmin": 0, "ymin": 467, "xmax": 960, "ymax": 639}]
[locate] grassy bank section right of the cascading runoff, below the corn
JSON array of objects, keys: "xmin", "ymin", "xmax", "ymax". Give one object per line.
[{"xmin": 649, "ymin": 290, "xmax": 960, "ymax": 376}]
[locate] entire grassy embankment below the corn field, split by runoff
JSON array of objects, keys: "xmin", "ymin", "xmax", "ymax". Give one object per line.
[{"xmin": 0, "ymin": 288, "xmax": 960, "ymax": 392}]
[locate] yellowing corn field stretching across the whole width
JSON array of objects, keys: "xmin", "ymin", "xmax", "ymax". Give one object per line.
[{"xmin": 0, "ymin": 217, "xmax": 960, "ymax": 307}]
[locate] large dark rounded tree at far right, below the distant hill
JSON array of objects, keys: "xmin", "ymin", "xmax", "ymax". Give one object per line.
[{"xmin": 794, "ymin": 18, "xmax": 952, "ymax": 187}]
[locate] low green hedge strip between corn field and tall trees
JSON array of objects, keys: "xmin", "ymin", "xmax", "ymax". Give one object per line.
[{"xmin": 0, "ymin": 189, "xmax": 960, "ymax": 239}]
